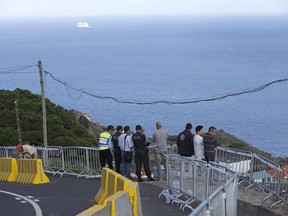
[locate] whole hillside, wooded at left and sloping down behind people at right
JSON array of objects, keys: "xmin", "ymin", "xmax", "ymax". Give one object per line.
[{"xmin": 0, "ymin": 89, "xmax": 288, "ymax": 164}]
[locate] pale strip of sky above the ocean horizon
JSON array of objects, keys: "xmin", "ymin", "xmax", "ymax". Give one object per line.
[{"xmin": 0, "ymin": 0, "xmax": 288, "ymax": 17}]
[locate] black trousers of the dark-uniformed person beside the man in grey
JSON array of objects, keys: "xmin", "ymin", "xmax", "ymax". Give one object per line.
[{"xmin": 135, "ymin": 149, "xmax": 151, "ymax": 178}]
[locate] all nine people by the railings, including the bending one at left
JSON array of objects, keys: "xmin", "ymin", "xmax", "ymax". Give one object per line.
[{"xmin": 16, "ymin": 122, "xmax": 219, "ymax": 182}]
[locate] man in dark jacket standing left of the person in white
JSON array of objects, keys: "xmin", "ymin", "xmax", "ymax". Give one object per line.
[{"xmin": 177, "ymin": 123, "xmax": 194, "ymax": 157}]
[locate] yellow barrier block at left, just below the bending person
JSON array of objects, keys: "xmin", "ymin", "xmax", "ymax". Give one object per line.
[{"xmin": 15, "ymin": 159, "xmax": 50, "ymax": 184}]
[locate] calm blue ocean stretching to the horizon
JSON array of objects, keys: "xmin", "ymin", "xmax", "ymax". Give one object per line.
[{"xmin": 0, "ymin": 16, "xmax": 288, "ymax": 157}]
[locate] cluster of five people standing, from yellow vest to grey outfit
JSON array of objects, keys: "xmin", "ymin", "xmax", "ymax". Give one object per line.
[{"xmin": 99, "ymin": 122, "xmax": 168, "ymax": 182}]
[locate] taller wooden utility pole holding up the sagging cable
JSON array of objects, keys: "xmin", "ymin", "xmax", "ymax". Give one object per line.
[{"xmin": 38, "ymin": 60, "xmax": 48, "ymax": 148}]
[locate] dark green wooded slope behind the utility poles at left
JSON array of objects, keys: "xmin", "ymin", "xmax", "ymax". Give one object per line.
[{"xmin": 0, "ymin": 89, "xmax": 97, "ymax": 146}]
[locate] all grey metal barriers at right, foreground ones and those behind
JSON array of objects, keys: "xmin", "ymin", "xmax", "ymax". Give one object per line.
[{"xmin": 159, "ymin": 147, "xmax": 288, "ymax": 216}]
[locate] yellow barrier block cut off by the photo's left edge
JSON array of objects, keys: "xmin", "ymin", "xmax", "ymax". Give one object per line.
[{"xmin": 0, "ymin": 158, "xmax": 18, "ymax": 182}]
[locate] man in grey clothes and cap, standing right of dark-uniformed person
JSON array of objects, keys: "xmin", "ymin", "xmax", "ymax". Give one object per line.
[{"xmin": 152, "ymin": 122, "xmax": 168, "ymax": 181}]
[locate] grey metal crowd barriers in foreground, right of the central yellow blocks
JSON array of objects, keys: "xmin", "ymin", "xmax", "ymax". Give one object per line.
[{"xmin": 159, "ymin": 155, "xmax": 238, "ymax": 215}]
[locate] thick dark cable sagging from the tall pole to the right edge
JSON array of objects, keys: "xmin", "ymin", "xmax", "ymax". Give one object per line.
[{"xmin": 44, "ymin": 71, "xmax": 288, "ymax": 105}]
